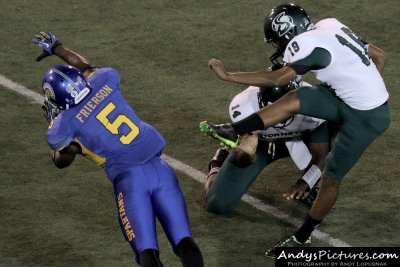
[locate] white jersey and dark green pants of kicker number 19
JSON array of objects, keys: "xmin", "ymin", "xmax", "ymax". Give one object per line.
[{"xmin": 284, "ymin": 18, "xmax": 390, "ymax": 180}]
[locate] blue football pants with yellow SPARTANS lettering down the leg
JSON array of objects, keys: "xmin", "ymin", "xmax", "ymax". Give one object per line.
[{"xmin": 114, "ymin": 157, "xmax": 192, "ymax": 262}]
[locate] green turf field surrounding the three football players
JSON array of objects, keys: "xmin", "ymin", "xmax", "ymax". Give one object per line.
[{"xmin": 0, "ymin": 0, "xmax": 400, "ymax": 267}]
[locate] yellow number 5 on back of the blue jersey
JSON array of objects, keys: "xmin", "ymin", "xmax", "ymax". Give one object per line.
[{"xmin": 96, "ymin": 102, "xmax": 139, "ymax": 145}]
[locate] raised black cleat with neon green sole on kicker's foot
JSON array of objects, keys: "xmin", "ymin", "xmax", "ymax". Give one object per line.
[{"xmin": 200, "ymin": 121, "xmax": 239, "ymax": 148}]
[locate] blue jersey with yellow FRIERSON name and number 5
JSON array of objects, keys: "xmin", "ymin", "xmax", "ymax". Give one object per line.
[{"xmin": 46, "ymin": 68, "xmax": 165, "ymax": 181}]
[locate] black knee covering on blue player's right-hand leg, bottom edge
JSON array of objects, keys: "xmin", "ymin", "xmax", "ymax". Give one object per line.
[{"xmin": 176, "ymin": 237, "xmax": 204, "ymax": 267}]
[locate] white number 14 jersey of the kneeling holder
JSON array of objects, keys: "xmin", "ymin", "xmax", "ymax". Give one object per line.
[{"xmin": 229, "ymin": 85, "xmax": 324, "ymax": 170}]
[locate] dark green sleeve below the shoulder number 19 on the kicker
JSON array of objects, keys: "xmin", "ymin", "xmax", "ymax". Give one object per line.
[{"xmin": 288, "ymin": 47, "xmax": 332, "ymax": 75}]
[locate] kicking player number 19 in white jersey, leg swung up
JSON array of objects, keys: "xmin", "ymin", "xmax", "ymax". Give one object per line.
[{"xmin": 200, "ymin": 4, "xmax": 390, "ymax": 256}]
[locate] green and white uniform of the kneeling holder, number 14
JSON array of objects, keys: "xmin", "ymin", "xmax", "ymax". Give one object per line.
[{"xmin": 206, "ymin": 84, "xmax": 329, "ymax": 214}]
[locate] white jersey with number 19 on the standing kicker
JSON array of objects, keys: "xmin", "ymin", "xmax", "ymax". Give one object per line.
[{"xmin": 283, "ymin": 18, "xmax": 389, "ymax": 110}]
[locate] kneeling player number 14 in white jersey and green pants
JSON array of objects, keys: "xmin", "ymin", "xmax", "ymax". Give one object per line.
[{"xmin": 204, "ymin": 78, "xmax": 329, "ymax": 214}]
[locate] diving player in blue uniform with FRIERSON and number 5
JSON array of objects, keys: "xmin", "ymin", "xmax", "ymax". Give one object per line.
[{"xmin": 33, "ymin": 32, "xmax": 204, "ymax": 267}]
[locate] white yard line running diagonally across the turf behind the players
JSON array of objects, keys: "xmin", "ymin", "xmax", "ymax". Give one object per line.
[{"xmin": 0, "ymin": 74, "xmax": 350, "ymax": 247}]
